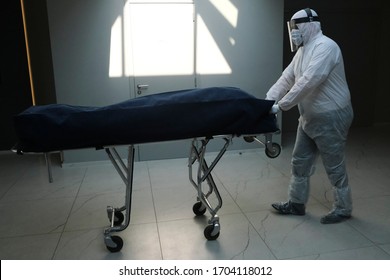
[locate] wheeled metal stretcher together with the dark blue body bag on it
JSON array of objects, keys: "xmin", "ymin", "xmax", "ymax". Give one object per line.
[{"xmin": 13, "ymin": 87, "xmax": 281, "ymax": 252}]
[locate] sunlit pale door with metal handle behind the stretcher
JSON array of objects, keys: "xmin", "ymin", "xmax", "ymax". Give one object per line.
[{"xmin": 125, "ymin": 1, "xmax": 196, "ymax": 160}]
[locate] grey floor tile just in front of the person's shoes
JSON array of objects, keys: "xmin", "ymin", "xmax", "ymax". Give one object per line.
[{"xmin": 247, "ymin": 202, "xmax": 373, "ymax": 259}]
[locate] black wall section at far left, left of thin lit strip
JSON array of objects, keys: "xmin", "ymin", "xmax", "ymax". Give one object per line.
[{"xmin": 0, "ymin": 1, "xmax": 32, "ymax": 150}]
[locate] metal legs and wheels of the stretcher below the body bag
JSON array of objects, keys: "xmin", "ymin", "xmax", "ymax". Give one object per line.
[{"xmin": 98, "ymin": 133, "xmax": 281, "ymax": 252}]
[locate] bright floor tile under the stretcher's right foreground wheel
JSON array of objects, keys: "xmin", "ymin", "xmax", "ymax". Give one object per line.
[{"xmin": 158, "ymin": 214, "xmax": 274, "ymax": 260}]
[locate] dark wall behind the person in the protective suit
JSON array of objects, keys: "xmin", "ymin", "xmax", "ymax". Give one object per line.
[{"xmin": 282, "ymin": 0, "xmax": 390, "ymax": 131}]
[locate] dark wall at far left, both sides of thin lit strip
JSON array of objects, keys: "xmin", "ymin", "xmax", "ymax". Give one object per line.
[{"xmin": 0, "ymin": 0, "xmax": 56, "ymax": 150}]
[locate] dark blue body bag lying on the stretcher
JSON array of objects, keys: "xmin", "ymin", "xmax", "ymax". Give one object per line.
[{"xmin": 14, "ymin": 87, "xmax": 278, "ymax": 152}]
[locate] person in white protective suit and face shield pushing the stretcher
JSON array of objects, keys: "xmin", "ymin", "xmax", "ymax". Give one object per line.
[{"xmin": 266, "ymin": 8, "xmax": 353, "ymax": 224}]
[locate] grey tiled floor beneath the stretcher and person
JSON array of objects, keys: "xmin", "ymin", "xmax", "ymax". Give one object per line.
[{"xmin": 0, "ymin": 126, "xmax": 390, "ymax": 260}]
